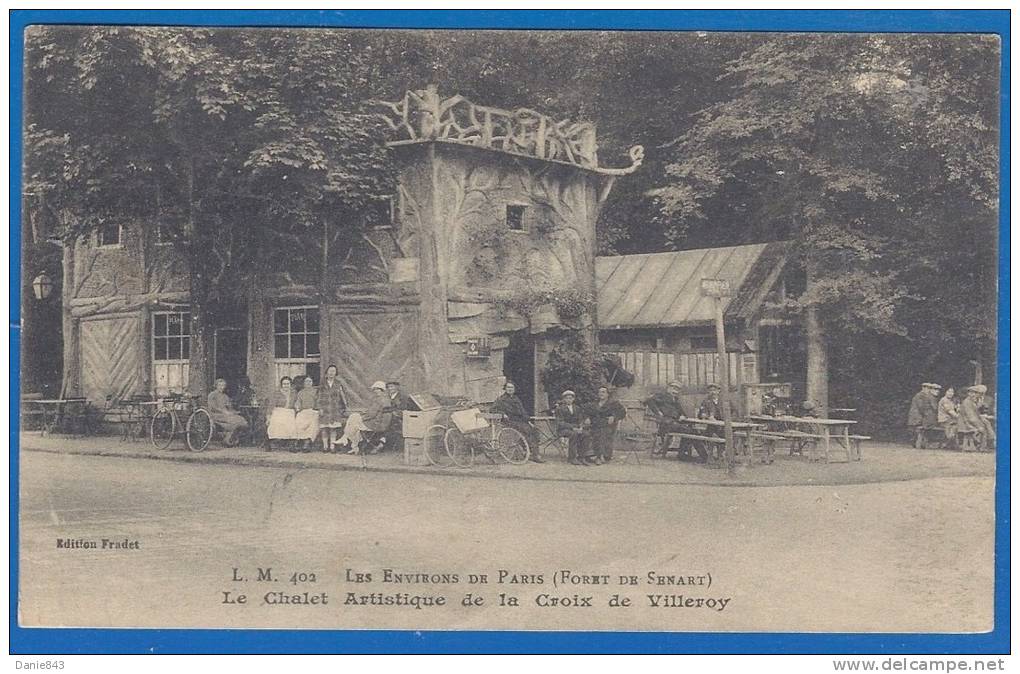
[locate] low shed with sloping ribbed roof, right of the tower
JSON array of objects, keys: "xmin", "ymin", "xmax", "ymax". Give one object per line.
[{"xmin": 596, "ymin": 242, "xmax": 805, "ymax": 411}]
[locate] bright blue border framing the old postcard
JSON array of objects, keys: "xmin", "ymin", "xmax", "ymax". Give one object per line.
[{"xmin": 9, "ymin": 9, "xmax": 1010, "ymax": 655}]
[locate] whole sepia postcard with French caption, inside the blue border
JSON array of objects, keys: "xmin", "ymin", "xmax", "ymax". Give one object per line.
[{"xmin": 11, "ymin": 9, "xmax": 1009, "ymax": 647}]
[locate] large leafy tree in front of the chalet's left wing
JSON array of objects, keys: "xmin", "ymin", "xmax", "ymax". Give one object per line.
[{"xmin": 26, "ymin": 27, "xmax": 393, "ymax": 392}]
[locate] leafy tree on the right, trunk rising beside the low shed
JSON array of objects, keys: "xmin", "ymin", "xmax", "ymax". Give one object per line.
[{"xmin": 652, "ymin": 35, "xmax": 998, "ymax": 416}]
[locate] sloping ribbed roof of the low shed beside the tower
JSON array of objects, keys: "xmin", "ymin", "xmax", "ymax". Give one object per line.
[{"xmin": 595, "ymin": 242, "xmax": 787, "ymax": 328}]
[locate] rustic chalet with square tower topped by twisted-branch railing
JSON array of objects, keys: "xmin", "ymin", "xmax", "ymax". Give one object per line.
[{"xmin": 64, "ymin": 89, "xmax": 640, "ymax": 405}]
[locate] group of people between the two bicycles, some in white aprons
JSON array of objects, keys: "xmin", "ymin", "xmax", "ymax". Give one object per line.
[{"xmin": 207, "ymin": 365, "xmax": 415, "ymax": 454}]
